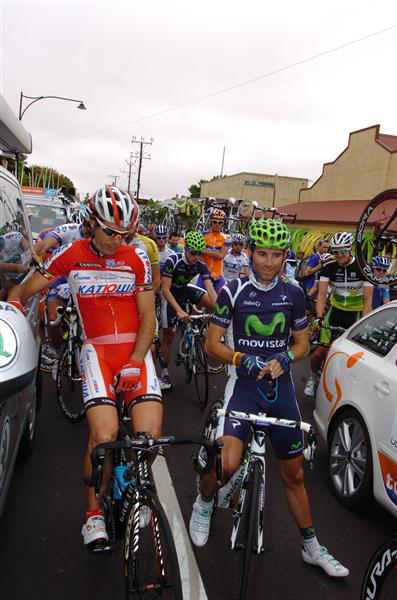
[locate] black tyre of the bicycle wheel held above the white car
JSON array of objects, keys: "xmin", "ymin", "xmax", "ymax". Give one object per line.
[{"xmin": 355, "ymin": 189, "xmax": 397, "ymax": 285}]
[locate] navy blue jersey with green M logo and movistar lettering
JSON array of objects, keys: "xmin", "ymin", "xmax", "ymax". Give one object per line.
[{"xmin": 211, "ymin": 273, "xmax": 307, "ymax": 376}]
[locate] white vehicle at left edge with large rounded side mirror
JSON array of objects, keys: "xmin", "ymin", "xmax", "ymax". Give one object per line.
[{"xmin": 0, "ymin": 95, "xmax": 41, "ymax": 514}]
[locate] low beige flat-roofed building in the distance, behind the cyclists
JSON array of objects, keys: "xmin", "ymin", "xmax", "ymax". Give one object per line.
[{"xmin": 200, "ymin": 172, "xmax": 308, "ymax": 208}]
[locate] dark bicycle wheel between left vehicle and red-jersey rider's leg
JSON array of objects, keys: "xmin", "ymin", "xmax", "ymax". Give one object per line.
[{"xmin": 56, "ymin": 348, "xmax": 85, "ymax": 423}]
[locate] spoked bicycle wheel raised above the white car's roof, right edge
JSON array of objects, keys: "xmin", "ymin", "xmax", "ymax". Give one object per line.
[{"xmin": 355, "ymin": 190, "xmax": 397, "ymax": 285}]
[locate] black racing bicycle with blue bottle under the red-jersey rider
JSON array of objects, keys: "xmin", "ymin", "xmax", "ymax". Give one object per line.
[{"xmin": 85, "ymin": 394, "xmax": 222, "ymax": 600}]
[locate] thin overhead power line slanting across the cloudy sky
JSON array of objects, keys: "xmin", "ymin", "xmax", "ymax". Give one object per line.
[{"xmin": 37, "ymin": 23, "xmax": 397, "ymax": 148}]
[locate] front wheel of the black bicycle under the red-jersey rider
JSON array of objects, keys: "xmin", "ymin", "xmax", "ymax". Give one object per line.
[{"xmin": 124, "ymin": 490, "xmax": 183, "ymax": 600}]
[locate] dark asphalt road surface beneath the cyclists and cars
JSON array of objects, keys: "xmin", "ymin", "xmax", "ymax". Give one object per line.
[{"xmin": 0, "ymin": 356, "xmax": 395, "ymax": 600}]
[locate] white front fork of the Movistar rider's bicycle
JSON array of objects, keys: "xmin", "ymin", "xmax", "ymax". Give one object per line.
[{"xmin": 230, "ymin": 430, "xmax": 266, "ymax": 554}]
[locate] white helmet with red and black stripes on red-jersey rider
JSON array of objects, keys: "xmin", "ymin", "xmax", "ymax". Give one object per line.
[{"xmin": 90, "ymin": 185, "xmax": 139, "ymax": 229}]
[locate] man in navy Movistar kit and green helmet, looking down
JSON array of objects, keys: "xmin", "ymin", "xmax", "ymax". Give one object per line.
[{"xmin": 189, "ymin": 219, "xmax": 349, "ymax": 577}]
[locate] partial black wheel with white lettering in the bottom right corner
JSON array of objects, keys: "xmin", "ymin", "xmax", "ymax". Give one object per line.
[{"xmin": 360, "ymin": 534, "xmax": 397, "ymax": 600}]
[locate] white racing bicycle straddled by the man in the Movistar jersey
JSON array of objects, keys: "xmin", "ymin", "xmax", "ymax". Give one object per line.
[{"xmin": 195, "ymin": 398, "xmax": 317, "ymax": 600}]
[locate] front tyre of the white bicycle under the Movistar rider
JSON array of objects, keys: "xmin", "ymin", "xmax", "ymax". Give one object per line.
[{"xmin": 236, "ymin": 461, "xmax": 261, "ymax": 600}]
